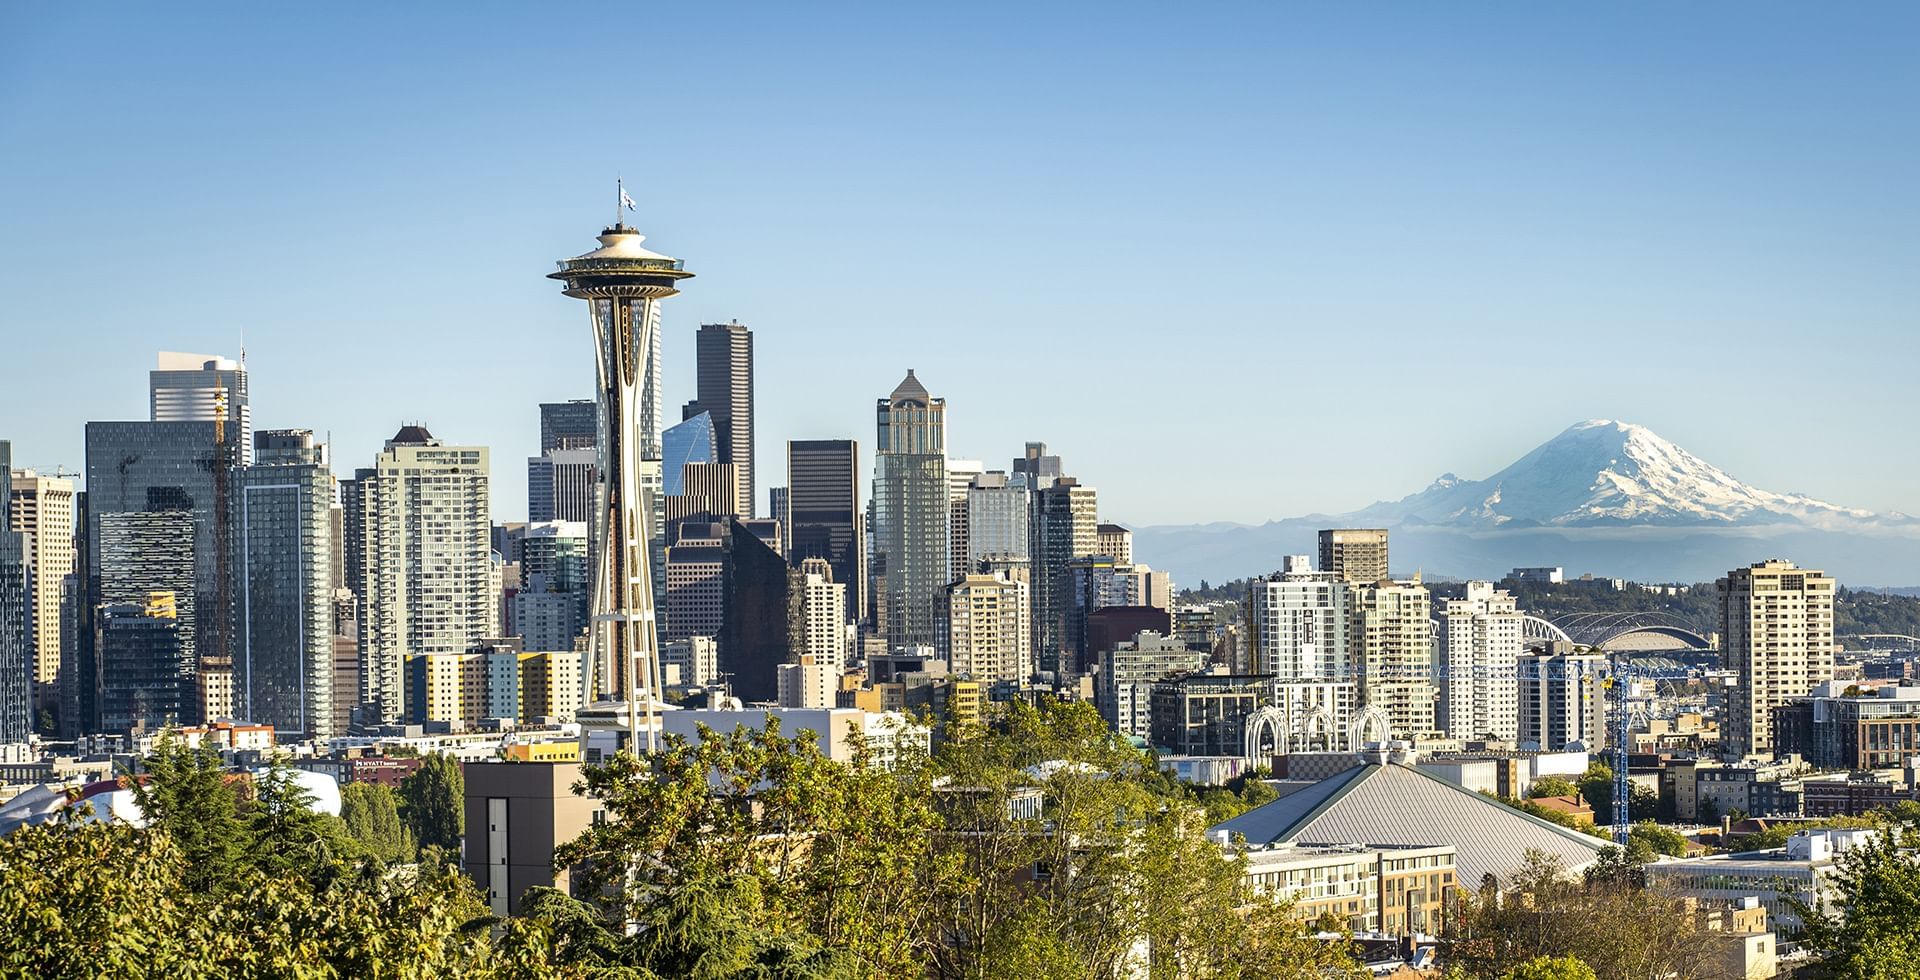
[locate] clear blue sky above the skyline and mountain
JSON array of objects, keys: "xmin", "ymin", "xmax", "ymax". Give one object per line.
[{"xmin": 0, "ymin": 2, "xmax": 1920, "ymax": 525}]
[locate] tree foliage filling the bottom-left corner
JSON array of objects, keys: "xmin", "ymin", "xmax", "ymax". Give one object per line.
[{"xmin": 0, "ymin": 740, "xmax": 493, "ymax": 978}]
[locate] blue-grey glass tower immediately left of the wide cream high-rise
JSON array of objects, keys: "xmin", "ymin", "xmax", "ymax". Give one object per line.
[{"xmin": 230, "ymin": 429, "xmax": 346, "ymax": 738}]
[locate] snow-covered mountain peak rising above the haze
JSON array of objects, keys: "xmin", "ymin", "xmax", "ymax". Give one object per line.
[{"xmin": 1354, "ymin": 419, "xmax": 1876, "ymax": 527}]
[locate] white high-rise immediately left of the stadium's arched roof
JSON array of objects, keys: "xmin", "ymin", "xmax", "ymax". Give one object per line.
[{"xmin": 1438, "ymin": 582, "xmax": 1526, "ymax": 740}]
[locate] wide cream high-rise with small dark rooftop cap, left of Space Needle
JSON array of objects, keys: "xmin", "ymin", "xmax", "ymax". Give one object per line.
[{"xmin": 361, "ymin": 425, "xmax": 499, "ymax": 723}]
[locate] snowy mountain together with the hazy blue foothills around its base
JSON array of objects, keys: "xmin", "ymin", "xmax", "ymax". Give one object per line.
[{"xmin": 1135, "ymin": 419, "xmax": 1920, "ymax": 584}]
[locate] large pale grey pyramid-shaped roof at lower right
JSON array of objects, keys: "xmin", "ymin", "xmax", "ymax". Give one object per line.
[{"xmin": 1213, "ymin": 763, "xmax": 1607, "ymax": 888}]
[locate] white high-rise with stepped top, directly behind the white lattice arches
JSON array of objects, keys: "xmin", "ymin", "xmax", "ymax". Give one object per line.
[{"xmin": 1248, "ymin": 555, "xmax": 1354, "ymax": 680}]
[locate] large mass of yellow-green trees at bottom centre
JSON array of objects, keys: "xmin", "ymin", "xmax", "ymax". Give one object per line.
[{"xmin": 529, "ymin": 703, "xmax": 1352, "ymax": 980}]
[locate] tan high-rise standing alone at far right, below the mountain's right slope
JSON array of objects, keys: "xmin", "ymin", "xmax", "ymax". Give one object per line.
[{"xmin": 1716, "ymin": 557, "xmax": 1834, "ymax": 761}]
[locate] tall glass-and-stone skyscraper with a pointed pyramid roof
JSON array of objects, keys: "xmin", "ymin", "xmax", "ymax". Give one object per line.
[{"xmin": 874, "ymin": 371, "xmax": 950, "ymax": 649}]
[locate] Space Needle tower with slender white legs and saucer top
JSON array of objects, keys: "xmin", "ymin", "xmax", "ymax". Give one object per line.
[{"xmin": 547, "ymin": 212, "xmax": 693, "ymax": 751}]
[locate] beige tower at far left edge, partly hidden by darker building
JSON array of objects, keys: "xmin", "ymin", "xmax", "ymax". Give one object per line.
[{"xmin": 8, "ymin": 461, "xmax": 79, "ymax": 726}]
